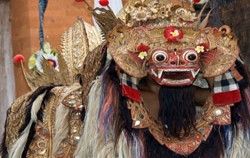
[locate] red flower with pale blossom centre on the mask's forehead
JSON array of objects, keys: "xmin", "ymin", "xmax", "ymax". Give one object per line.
[{"xmin": 164, "ymin": 26, "xmax": 183, "ymax": 42}]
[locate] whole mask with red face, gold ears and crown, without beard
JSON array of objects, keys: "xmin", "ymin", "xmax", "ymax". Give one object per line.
[{"xmin": 101, "ymin": 0, "xmax": 239, "ymax": 86}]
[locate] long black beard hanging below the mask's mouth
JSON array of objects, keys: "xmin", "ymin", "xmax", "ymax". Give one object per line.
[{"xmin": 159, "ymin": 86, "xmax": 196, "ymax": 138}]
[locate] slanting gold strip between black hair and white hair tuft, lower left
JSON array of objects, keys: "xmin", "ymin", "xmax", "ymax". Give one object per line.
[{"xmin": 26, "ymin": 87, "xmax": 64, "ymax": 158}]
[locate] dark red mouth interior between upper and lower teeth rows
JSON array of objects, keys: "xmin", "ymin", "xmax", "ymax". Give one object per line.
[{"xmin": 162, "ymin": 72, "xmax": 191, "ymax": 80}]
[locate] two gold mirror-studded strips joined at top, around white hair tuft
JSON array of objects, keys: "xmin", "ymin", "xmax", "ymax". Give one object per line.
[{"xmin": 24, "ymin": 85, "xmax": 83, "ymax": 158}]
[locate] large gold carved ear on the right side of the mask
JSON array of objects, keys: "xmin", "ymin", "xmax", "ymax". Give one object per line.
[{"xmin": 200, "ymin": 28, "xmax": 240, "ymax": 78}]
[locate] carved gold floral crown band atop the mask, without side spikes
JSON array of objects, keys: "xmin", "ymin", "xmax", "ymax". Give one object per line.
[{"xmin": 120, "ymin": 0, "xmax": 205, "ymax": 28}]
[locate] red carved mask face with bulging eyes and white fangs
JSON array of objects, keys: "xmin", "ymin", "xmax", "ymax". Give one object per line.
[{"xmin": 147, "ymin": 47, "xmax": 200, "ymax": 86}]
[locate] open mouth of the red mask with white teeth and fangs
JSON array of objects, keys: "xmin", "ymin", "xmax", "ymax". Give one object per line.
[{"xmin": 149, "ymin": 69, "xmax": 200, "ymax": 86}]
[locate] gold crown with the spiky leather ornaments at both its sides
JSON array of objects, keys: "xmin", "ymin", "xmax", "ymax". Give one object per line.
[{"xmin": 89, "ymin": 0, "xmax": 211, "ymax": 34}]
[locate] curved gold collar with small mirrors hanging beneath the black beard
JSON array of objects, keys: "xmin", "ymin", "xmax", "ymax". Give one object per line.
[{"xmin": 127, "ymin": 96, "xmax": 231, "ymax": 155}]
